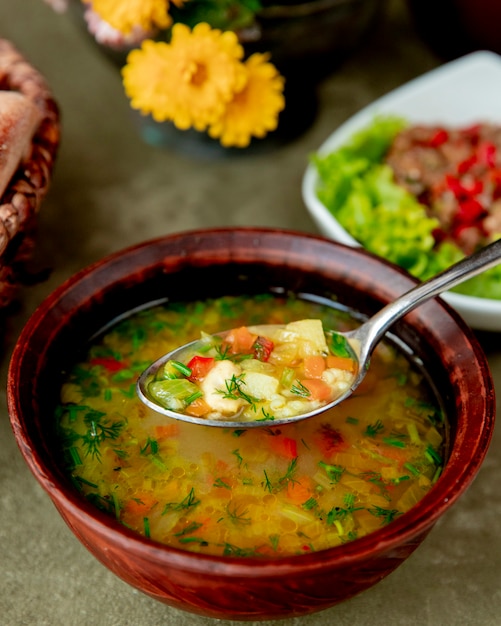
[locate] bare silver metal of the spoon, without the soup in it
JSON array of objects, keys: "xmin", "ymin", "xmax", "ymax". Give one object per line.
[{"xmin": 137, "ymin": 240, "xmax": 501, "ymax": 428}]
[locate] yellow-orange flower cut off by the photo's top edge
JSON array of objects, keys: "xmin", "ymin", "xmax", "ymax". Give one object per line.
[{"xmin": 91, "ymin": 0, "xmax": 172, "ymax": 35}]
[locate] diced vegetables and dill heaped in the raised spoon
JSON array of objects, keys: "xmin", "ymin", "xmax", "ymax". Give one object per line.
[{"xmin": 145, "ymin": 319, "xmax": 358, "ymax": 424}]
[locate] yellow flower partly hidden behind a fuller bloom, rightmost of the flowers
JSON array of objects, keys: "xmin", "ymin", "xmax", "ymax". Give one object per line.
[{"xmin": 209, "ymin": 53, "xmax": 285, "ymax": 148}]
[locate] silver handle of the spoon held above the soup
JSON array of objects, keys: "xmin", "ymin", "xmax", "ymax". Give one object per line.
[{"xmin": 352, "ymin": 239, "xmax": 501, "ymax": 362}]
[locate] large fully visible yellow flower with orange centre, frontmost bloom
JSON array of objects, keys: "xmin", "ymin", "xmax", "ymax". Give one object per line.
[{"xmin": 122, "ymin": 22, "xmax": 246, "ymax": 130}]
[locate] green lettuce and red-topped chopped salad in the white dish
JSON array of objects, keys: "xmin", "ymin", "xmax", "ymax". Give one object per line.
[{"xmin": 312, "ymin": 116, "xmax": 501, "ymax": 299}]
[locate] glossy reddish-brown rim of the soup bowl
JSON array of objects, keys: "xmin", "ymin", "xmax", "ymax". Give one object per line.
[{"xmin": 7, "ymin": 227, "xmax": 495, "ymax": 578}]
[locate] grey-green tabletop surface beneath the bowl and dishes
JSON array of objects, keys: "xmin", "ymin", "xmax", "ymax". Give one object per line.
[{"xmin": 0, "ymin": 0, "xmax": 501, "ymax": 626}]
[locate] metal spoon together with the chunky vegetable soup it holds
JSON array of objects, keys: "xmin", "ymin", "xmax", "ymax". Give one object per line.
[{"xmin": 137, "ymin": 240, "xmax": 501, "ymax": 428}]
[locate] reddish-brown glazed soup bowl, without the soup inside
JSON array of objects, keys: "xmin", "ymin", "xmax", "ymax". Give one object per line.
[{"xmin": 8, "ymin": 228, "xmax": 495, "ymax": 620}]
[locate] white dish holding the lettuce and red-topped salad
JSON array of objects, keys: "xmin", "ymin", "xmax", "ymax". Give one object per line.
[{"xmin": 302, "ymin": 51, "xmax": 501, "ymax": 331}]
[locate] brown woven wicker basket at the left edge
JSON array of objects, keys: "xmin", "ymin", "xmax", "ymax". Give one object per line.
[{"xmin": 0, "ymin": 39, "xmax": 60, "ymax": 309}]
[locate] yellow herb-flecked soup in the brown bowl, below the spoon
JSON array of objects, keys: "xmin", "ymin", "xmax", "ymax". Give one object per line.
[{"xmin": 56, "ymin": 295, "xmax": 446, "ymax": 556}]
